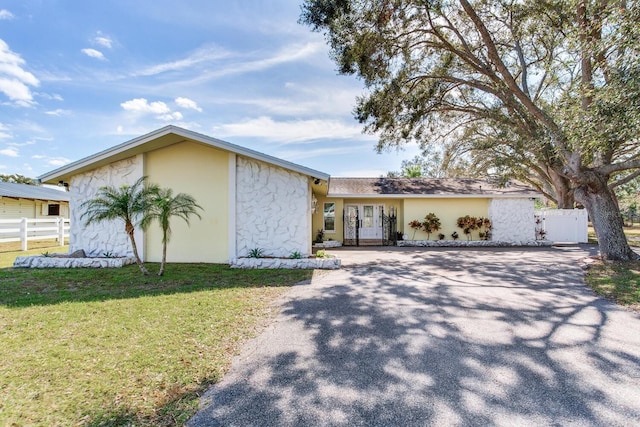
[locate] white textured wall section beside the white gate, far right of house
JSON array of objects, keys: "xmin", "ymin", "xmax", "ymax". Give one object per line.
[{"xmin": 489, "ymin": 199, "xmax": 536, "ymax": 243}]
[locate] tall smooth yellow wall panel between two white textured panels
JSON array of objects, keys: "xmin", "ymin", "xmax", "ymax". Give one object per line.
[{"xmin": 144, "ymin": 142, "xmax": 229, "ymax": 263}]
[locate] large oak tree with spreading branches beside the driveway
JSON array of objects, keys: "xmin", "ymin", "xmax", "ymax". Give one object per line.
[{"xmin": 301, "ymin": 0, "xmax": 640, "ymax": 260}]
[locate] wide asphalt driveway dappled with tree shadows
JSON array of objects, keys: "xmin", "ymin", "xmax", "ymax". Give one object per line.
[{"xmin": 189, "ymin": 246, "xmax": 640, "ymax": 426}]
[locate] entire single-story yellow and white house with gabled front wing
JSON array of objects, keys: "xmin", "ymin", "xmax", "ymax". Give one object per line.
[{"xmin": 39, "ymin": 126, "xmax": 540, "ymax": 263}]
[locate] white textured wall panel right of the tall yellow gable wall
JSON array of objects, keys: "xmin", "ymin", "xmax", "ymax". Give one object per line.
[{"xmin": 236, "ymin": 156, "xmax": 311, "ymax": 257}]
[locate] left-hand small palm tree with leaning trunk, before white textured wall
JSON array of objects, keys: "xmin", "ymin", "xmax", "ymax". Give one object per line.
[{"xmin": 81, "ymin": 176, "xmax": 157, "ymax": 274}]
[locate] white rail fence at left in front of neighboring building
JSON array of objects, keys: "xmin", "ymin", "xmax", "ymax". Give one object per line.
[{"xmin": 0, "ymin": 218, "xmax": 70, "ymax": 251}]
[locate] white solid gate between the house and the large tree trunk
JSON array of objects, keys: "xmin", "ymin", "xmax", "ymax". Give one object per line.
[{"xmin": 535, "ymin": 209, "xmax": 589, "ymax": 243}]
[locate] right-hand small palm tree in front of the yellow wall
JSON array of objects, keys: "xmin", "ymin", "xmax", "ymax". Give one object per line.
[{"xmin": 145, "ymin": 188, "xmax": 202, "ymax": 276}]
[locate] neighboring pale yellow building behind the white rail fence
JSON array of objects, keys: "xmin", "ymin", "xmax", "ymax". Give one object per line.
[{"xmin": 0, "ymin": 182, "xmax": 69, "ymax": 219}]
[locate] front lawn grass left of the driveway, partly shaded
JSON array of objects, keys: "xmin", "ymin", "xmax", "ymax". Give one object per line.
[{"xmin": 0, "ymin": 262, "xmax": 312, "ymax": 426}]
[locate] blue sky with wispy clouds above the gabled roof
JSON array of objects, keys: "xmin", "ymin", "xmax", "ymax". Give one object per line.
[{"xmin": 0, "ymin": 0, "xmax": 417, "ymax": 177}]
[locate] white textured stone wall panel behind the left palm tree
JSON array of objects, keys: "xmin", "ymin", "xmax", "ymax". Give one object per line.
[{"xmin": 69, "ymin": 155, "xmax": 144, "ymax": 259}]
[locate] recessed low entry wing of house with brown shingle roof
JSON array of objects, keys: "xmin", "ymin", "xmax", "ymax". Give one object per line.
[{"xmin": 313, "ymin": 178, "xmax": 541, "ymax": 244}]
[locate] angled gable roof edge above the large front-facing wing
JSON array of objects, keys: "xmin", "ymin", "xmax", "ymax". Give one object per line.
[{"xmin": 38, "ymin": 125, "xmax": 329, "ymax": 183}]
